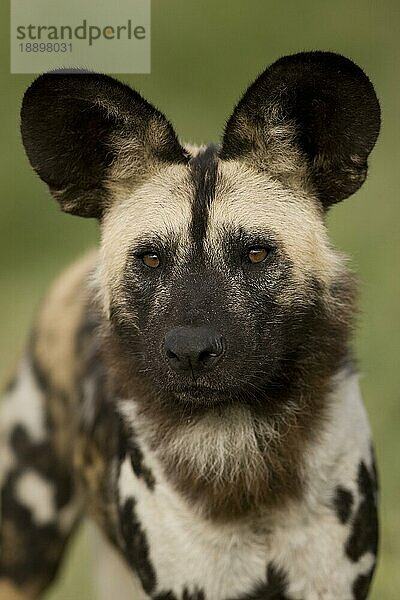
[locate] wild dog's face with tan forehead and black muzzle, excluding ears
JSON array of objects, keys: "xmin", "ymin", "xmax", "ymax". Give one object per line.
[{"xmin": 100, "ymin": 147, "xmax": 343, "ymax": 403}]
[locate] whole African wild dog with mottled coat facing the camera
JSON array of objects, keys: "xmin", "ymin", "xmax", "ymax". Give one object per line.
[{"xmin": 0, "ymin": 52, "xmax": 380, "ymax": 600}]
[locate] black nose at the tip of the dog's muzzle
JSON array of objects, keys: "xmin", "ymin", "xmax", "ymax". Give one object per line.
[{"xmin": 164, "ymin": 327, "xmax": 225, "ymax": 374}]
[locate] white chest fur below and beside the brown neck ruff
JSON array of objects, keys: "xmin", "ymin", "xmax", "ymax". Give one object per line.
[{"xmin": 95, "ymin": 375, "xmax": 374, "ymax": 600}]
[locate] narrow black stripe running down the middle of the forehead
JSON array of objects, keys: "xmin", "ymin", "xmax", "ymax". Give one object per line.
[{"xmin": 189, "ymin": 144, "xmax": 218, "ymax": 246}]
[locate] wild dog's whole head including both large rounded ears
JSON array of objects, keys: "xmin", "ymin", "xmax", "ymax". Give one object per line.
[{"xmin": 22, "ymin": 52, "xmax": 379, "ymax": 406}]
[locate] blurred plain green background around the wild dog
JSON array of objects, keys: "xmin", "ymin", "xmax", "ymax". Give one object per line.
[{"xmin": 0, "ymin": 0, "xmax": 400, "ymax": 600}]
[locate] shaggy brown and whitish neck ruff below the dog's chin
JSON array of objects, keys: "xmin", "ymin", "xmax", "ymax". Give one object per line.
[{"xmin": 101, "ymin": 330, "xmax": 354, "ymax": 521}]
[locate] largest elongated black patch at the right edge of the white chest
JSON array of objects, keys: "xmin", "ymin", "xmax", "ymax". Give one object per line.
[{"xmin": 346, "ymin": 461, "xmax": 378, "ymax": 562}]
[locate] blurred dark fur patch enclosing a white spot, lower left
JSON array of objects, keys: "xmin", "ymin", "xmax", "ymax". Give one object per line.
[{"xmin": 0, "ymin": 425, "xmax": 78, "ymax": 585}]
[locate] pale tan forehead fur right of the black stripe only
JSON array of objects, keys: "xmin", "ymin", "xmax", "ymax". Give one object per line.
[{"xmin": 207, "ymin": 161, "xmax": 343, "ymax": 287}]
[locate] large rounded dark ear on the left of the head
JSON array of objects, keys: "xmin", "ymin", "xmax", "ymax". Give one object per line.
[{"xmin": 21, "ymin": 71, "xmax": 187, "ymax": 217}]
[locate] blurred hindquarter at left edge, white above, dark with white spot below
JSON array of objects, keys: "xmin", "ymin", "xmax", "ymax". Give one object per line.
[{"xmin": 0, "ymin": 353, "xmax": 81, "ymax": 593}]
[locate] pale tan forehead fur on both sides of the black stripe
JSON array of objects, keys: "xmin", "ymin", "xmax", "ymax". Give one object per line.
[{"xmin": 96, "ymin": 147, "xmax": 345, "ymax": 322}]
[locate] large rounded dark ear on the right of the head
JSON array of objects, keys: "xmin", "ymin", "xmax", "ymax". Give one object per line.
[{"xmin": 221, "ymin": 51, "xmax": 380, "ymax": 208}]
